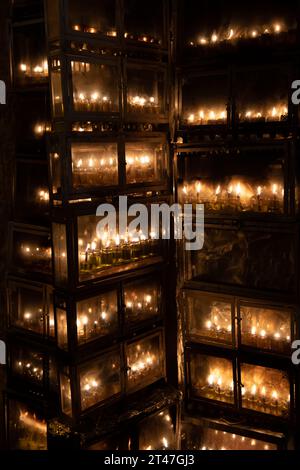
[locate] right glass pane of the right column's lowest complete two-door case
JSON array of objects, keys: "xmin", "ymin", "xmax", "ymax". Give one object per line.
[{"xmin": 241, "ymin": 364, "xmax": 290, "ymax": 418}]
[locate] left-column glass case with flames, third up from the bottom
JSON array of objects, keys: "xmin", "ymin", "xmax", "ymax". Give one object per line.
[{"xmin": 8, "ymin": 280, "xmax": 55, "ymax": 338}]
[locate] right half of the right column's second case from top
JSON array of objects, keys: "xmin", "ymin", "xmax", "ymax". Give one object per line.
[{"xmin": 236, "ymin": 67, "xmax": 290, "ymax": 123}]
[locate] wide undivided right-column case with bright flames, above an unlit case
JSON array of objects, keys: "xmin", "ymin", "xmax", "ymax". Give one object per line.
[{"xmin": 178, "ymin": 145, "xmax": 288, "ymax": 214}]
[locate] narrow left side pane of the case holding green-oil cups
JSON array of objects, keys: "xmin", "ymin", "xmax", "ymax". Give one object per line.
[{"xmin": 52, "ymin": 224, "xmax": 68, "ymax": 284}]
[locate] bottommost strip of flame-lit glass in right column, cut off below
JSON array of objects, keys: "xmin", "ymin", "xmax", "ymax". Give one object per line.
[{"xmin": 183, "ymin": 422, "xmax": 277, "ymax": 450}]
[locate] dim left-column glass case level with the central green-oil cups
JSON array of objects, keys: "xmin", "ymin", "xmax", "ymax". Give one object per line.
[{"xmin": 10, "ymin": 224, "xmax": 52, "ymax": 277}]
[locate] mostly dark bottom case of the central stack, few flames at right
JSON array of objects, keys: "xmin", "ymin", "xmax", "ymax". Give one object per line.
[{"xmin": 48, "ymin": 384, "xmax": 181, "ymax": 450}]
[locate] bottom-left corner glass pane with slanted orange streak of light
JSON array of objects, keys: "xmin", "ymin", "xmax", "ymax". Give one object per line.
[{"xmin": 8, "ymin": 400, "xmax": 47, "ymax": 450}]
